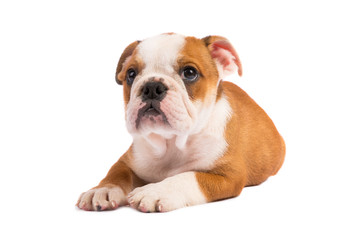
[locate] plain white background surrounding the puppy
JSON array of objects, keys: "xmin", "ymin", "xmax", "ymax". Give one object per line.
[{"xmin": 0, "ymin": 0, "xmax": 360, "ymax": 239}]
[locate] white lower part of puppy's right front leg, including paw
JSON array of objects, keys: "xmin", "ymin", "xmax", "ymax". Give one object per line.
[{"xmin": 128, "ymin": 172, "xmax": 206, "ymax": 212}]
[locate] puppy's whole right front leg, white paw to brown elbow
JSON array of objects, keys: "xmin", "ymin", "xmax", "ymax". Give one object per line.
[{"xmin": 128, "ymin": 172, "xmax": 244, "ymax": 212}]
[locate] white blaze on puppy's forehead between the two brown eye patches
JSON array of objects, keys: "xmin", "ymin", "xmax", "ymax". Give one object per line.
[{"xmin": 138, "ymin": 34, "xmax": 185, "ymax": 74}]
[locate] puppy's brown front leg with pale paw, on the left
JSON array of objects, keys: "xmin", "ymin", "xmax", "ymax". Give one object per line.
[{"xmin": 76, "ymin": 151, "xmax": 143, "ymax": 211}]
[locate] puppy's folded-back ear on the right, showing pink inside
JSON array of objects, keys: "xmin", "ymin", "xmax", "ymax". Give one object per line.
[{"xmin": 202, "ymin": 36, "xmax": 242, "ymax": 78}]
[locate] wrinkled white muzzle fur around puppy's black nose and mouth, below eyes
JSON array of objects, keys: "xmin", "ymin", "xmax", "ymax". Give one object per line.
[{"xmin": 126, "ymin": 73, "xmax": 198, "ymax": 155}]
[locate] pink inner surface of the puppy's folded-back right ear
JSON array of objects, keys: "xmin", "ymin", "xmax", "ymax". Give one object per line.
[{"xmin": 211, "ymin": 40, "xmax": 242, "ymax": 76}]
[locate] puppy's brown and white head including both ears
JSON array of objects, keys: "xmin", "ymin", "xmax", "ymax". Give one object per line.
[{"xmin": 116, "ymin": 34, "xmax": 241, "ymax": 143}]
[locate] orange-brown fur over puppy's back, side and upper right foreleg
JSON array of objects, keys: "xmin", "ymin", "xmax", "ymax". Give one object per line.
[{"xmin": 196, "ymin": 82, "xmax": 285, "ymax": 201}]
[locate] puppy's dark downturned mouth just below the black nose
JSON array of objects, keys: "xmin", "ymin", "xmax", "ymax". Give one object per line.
[{"xmin": 136, "ymin": 100, "xmax": 168, "ymax": 128}]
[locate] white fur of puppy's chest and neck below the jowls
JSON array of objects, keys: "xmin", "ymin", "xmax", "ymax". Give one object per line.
[{"xmin": 131, "ymin": 96, "xmax": 232, "ymax": 182}]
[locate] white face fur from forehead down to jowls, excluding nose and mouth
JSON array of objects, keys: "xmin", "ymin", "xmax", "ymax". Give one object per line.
[{"xmin": 126, "ymin": 34, "xmax": 197, "ymax": 154}]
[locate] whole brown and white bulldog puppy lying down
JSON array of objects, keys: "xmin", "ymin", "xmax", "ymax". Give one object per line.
[{"xmin": 77, "ymin": 34, "xmax": 285, "ymax": 212}]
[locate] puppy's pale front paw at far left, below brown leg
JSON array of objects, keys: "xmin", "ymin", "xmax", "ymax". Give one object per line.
[{"xmin": 76, "ymin": 186, "xmax": 127, "ymax": 211}]
